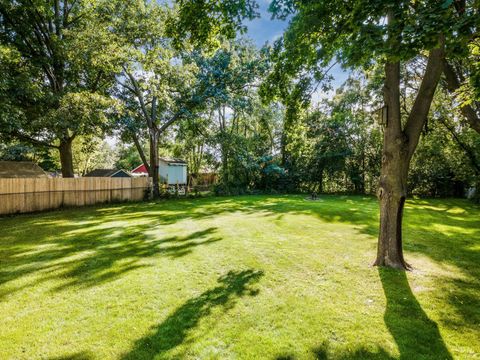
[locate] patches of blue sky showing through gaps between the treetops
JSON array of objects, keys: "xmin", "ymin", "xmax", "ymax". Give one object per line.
[{"xmin": 245, "ymin": 0, "xmax": 348, "ymax": 89}]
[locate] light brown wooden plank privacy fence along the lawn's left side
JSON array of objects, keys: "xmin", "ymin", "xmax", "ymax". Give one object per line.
[{"xmin": 0, "ymin": 177, "xmax": 150, "ymax": 215}]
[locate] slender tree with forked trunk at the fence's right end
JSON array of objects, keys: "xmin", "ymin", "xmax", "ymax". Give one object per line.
[{"xmin": 115, "ymin": 2, "xmax": 201, "ymax": 197}]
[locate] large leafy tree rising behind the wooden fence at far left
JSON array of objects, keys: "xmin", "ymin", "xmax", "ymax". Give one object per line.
[{"xmin": 0, "ymin": 0, "xmax": 123, "ymax": 177}]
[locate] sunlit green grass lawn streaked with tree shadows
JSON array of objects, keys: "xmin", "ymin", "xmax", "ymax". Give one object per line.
[{"xmin": 0, "ymin": 196, "xmax": 480, "ymax": 360}]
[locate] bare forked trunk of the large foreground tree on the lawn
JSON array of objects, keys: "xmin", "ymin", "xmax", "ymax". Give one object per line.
[{"xmin": 374, "ymin": 39, "xmax": 444, "ymax": 269}]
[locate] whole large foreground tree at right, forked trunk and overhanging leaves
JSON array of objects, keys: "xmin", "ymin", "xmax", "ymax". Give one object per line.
[{"xmin": 260, "ymin": 0, "xmax": 478, "ymax": 268}]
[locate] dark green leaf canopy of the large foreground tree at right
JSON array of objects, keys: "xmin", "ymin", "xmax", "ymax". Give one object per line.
[{"xmin": 263, "ymin": 0, "xmax": 480, "ymax": 104}]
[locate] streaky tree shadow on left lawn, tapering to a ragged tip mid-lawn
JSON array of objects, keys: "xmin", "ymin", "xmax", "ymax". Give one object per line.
[{"xmin": 0, "ymin": 221, "xmax": 221, "ymax": 300}]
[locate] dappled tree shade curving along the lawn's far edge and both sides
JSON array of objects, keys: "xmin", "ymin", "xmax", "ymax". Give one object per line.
[{"xmin": 0, "ymin": 196, "xmax": 480, "ymax": 325}]
